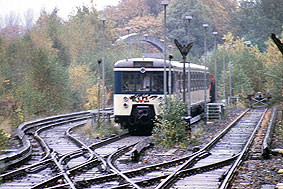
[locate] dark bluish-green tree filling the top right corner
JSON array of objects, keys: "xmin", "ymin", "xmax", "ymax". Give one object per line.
[{"xmin": 233, "ymin": 0, "xmax": 283, "ymax": 50}]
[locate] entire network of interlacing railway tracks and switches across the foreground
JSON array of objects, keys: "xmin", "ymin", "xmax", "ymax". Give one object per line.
[{"xmin": 0, "ymin": 110, "xmax": 270, "ymax": 189}]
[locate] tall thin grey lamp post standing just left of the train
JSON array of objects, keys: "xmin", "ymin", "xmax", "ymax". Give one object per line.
[{"xmin": 100, "ymin": 18, "xmax": 106, "ymax": 117}]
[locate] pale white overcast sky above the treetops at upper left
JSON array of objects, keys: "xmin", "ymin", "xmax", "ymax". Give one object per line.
[{"xmin": 0, "ymin": 0, "xmax": 119, "ymax": 19}]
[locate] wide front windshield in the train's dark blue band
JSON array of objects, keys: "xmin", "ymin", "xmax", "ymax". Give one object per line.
[{"xmin": 121, "ymin": 72, "xmax": 163, "ymax": 93}]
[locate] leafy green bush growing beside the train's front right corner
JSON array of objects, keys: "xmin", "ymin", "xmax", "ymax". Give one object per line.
[{"xmin": 152, "ymin": 98, "xmax": 190, "ymax": 149}]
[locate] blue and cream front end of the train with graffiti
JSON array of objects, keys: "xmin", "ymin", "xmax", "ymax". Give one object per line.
[{"xmin": 114, "ymin": 59, "xmax": 163, "ymax": 135}]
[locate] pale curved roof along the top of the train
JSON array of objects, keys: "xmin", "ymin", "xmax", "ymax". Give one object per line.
[{"xmin": 114, "ymin": 58, "xmax": 207, "ymax": 70}]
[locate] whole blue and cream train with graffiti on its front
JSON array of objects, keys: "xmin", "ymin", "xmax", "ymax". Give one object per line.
[{"xmin": 114, "ymin": 58, "xmax": 215, "ymax": 134}]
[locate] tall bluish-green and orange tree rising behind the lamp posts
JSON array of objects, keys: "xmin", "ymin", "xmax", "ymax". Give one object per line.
[{"xmin": 167, "ymin": 0, "xmax": 239, "ymax": 55}]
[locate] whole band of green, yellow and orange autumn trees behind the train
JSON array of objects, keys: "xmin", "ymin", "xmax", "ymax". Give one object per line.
[{"xmin": 0, "ymin": 0, "xmax": 283, "ymax": 129}]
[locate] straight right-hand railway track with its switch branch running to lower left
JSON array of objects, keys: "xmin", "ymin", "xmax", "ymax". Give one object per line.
[{"xmin": 70, "ymin": 110, "xmax": 264, "ymax": 188}]
